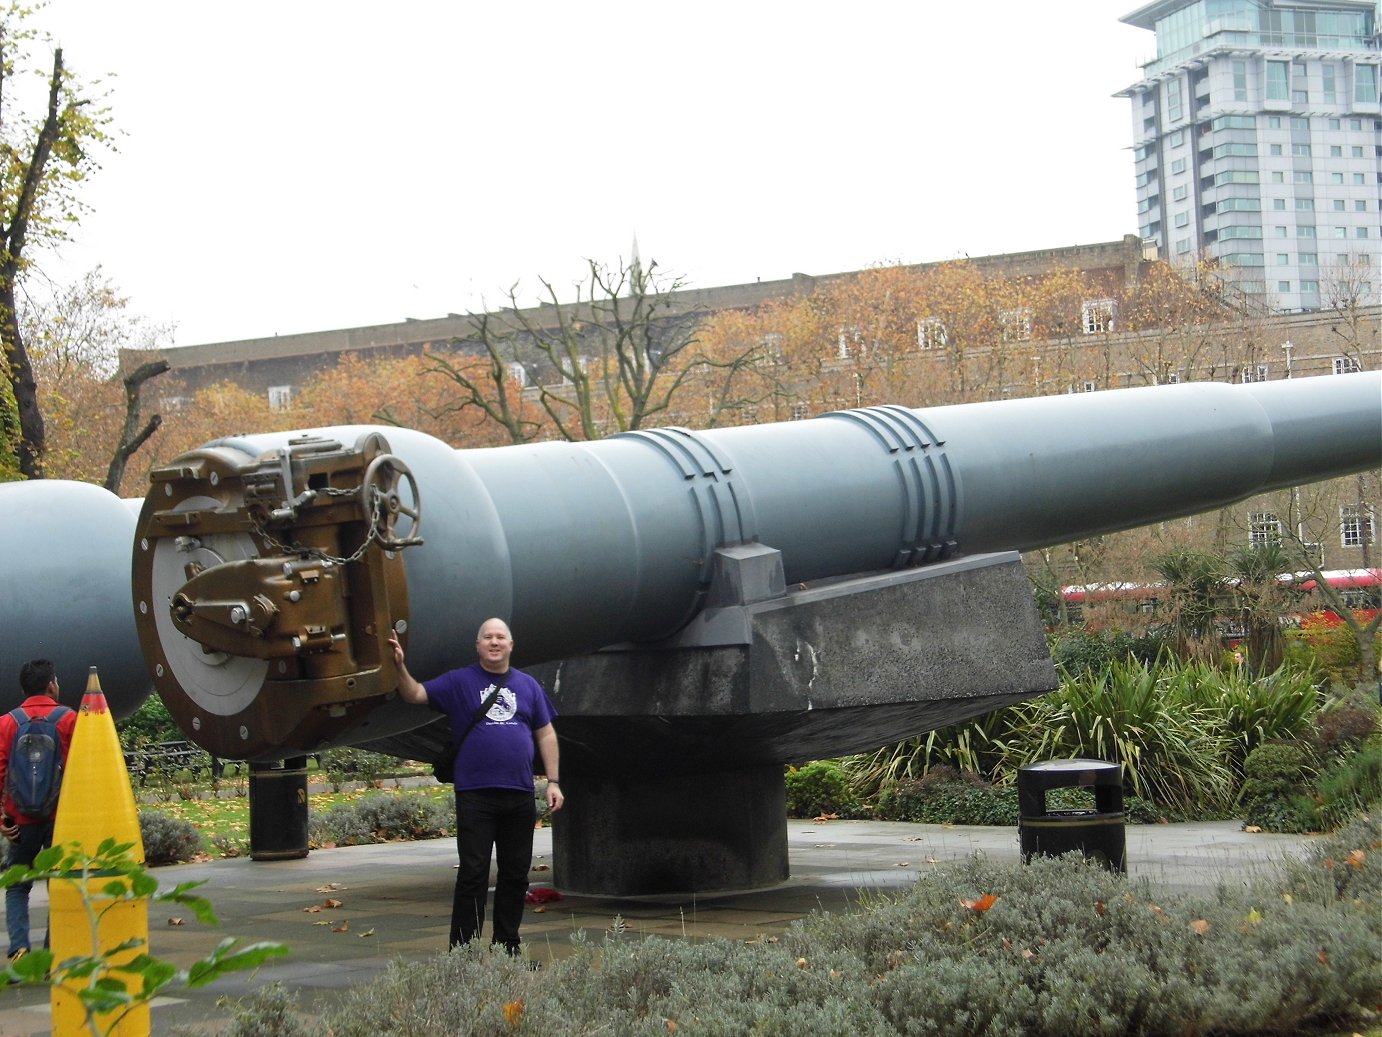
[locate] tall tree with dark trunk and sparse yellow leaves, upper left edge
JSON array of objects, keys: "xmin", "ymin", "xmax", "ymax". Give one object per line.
[{"xmin": 0, "ymin": 3, "xmax": 109, "ymax": 478}]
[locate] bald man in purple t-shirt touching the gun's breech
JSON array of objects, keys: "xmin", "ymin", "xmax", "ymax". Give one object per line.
[{"xmin": 388, "ymin": 619, "xmax": 565, "ymax": 954}]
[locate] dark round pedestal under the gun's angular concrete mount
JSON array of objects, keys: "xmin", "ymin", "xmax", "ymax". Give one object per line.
[{"xmin": 551, "ymin": 763, "xmax": 789, "ymax": 896}]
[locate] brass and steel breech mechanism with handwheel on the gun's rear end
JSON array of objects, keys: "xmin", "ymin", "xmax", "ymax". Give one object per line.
[{"xmin": 134, "ymin": 433, "xmax": 422, "ymax": 759}]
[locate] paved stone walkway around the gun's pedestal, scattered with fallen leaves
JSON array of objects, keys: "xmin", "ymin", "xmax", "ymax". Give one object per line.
[{"xmin": 0, "ymin": 821, "xmax": 1310, "ymax": 1037}]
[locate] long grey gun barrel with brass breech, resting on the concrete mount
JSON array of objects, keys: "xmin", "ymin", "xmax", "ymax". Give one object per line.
[{"xmin": 116, "ymin": 372, "xmax": 1382, "ymax": 758}]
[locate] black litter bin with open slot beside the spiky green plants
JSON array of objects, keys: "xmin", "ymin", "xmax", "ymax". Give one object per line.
[{"xmin": 1017, "ymin": 759, "xmax": 1128, "ymax": 872}]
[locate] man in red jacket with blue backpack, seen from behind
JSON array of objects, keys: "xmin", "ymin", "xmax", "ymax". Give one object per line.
[{"xmin": 0, "ymin": 660, "xmax": 77, "ymax": 961}]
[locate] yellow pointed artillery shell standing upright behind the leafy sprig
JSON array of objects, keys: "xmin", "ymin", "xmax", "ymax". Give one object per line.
[{"xmin": 48, "ymin": 666, "xmax": 152, "ymax": 1037}]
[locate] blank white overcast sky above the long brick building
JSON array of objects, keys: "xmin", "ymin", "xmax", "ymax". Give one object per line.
[{"xmin": 36, "ymin": 0, "xmax": 1154, "ymax": 344}]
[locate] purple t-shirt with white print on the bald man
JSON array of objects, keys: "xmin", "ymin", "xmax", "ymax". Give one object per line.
[{"xmin": 423, "ymin": 662, "xmax": 557, "ymax": 792}]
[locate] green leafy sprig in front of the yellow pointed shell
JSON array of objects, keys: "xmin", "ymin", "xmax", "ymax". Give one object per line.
[{"xmin": 0, "ymin": 839, "xmax": 287, "ymax": 1037}]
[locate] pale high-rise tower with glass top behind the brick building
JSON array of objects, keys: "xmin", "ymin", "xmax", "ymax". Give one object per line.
[{"xmin": 1119, "ymin": 0, "xmax": 1382, "ymax": 311}]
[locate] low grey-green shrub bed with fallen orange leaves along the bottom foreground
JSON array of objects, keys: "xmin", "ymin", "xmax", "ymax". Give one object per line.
[{"xmin": 305, "ymin": 835, "xmax": 1382, "ymax": 1037}]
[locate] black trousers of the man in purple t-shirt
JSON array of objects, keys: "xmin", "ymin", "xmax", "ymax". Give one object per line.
[{"xmin": 451, "ymin": 788, "xmax": 538, "ymax": 954}]
